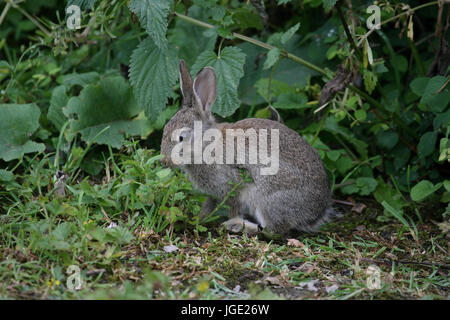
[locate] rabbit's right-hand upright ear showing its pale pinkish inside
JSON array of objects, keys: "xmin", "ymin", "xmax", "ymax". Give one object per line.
[{"xmin": 194, "ymin": 67, "xmax": 217, "ymax": 115}]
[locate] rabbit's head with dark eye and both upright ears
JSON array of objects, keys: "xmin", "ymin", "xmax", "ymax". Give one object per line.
[{"xmin": 161, "ymin": 60, "xmax": 217, "ymax": 166}]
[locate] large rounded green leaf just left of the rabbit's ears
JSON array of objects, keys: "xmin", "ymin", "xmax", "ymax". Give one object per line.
[{"xmin": 65, "ymin": 76, "xmax": 147, "ymax": 149}]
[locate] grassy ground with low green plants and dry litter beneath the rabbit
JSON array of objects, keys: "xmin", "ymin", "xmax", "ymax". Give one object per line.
[{"xmin": 0, "ymin": 143, "xmax": 450, "ymax": 299}]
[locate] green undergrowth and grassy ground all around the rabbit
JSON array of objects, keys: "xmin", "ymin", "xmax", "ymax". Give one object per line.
[{"xmin": 0, "ymin": 0, "xmax": 450, "ymax": 299}]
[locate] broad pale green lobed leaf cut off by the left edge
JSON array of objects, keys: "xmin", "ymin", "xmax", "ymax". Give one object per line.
[{"xmin": 0, "ymin": 103, "xmax": 45, "ymax": 161}]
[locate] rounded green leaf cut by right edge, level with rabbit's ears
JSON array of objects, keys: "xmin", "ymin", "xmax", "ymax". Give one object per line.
[{"xmin": 420, "ymin": 76, "xmax": 450, "ymax": 112}]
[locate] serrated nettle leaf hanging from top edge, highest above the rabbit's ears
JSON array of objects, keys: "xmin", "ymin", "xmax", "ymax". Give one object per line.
[{"xmin": 130, "ymin": 0, "xmax": 171, "ymax": 49}]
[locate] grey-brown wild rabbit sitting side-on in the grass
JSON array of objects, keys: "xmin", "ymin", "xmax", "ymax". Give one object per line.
[{"xmin": 161, "ymin": 60, "xmax": 334, "ymax": 235}]
